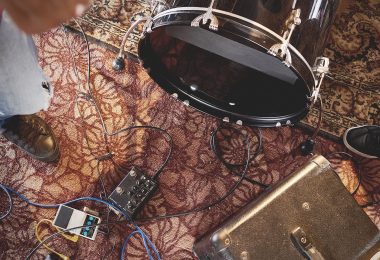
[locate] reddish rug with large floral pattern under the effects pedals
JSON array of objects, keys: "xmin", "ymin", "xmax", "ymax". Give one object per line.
[{"xmin": 0, "ymin": 23, "xmax": 380, "ymax": 260}]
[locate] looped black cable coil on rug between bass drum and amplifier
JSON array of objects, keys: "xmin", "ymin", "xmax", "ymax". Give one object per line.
[{"xmin": 210, "ymin": 124, "xmax": 269, "ymax": 189}]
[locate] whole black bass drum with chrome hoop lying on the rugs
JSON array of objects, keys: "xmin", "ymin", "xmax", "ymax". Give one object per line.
[{"xmin": 139, "ymin": 0, "xmax": 339, "ymax": 127}]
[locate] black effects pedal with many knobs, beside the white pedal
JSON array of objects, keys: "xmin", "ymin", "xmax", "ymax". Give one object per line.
[{"xmin": 108, "ymin": 167, "xmax": 157, "ymax": 219}]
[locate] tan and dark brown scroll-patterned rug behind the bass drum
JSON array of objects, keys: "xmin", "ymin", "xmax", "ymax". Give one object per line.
[{"xmin": 70, "ymin": 0, "xmax": 380, "ymax": 139}]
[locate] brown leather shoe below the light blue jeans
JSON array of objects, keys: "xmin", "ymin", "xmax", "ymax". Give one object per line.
[{"xmin": 1, "ymin": 115, "xmax": 59, "ymax": 162}]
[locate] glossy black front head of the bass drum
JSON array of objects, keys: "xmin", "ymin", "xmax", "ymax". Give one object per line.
[{"xmin": 139, "ymin": 17, "xmax": 310, "ymax": 127}]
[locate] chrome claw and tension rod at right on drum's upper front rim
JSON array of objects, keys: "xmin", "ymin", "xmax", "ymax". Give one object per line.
[{"xmin": 268, "ymin": 9, "xmax": 301, "ymax": 67}]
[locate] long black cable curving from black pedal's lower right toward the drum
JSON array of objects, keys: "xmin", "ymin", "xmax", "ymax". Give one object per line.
[{"xmin": 136, "ymin": 132, "xmax": 261, "ymax": 223}]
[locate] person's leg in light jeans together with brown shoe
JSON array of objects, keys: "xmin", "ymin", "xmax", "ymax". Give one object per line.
[{"xmin": 0, "ymin": 14, "xmax": 59, "ymax": 161}]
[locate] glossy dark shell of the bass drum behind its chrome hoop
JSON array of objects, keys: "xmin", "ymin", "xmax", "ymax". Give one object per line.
[{"xmin": 168, "ymin": 0, "xmax": 340, "ymax": 65}]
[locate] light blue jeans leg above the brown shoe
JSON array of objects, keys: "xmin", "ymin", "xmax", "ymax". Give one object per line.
[{"xmin": 0, "ymin": 12, "xmax": 53, "ymax": 118}]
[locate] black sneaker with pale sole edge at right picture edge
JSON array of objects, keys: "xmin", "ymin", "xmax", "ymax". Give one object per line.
[{"xmin": 343, "ymin": 125, "xmax": 380, "ymax": 158}]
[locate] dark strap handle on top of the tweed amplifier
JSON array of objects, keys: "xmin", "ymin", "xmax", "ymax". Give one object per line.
[{"xmin": 290, "ymin": 227, "xmax": 325, "ymax": 260}]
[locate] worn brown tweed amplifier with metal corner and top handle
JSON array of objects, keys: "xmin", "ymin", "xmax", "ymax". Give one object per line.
[{"xmin": 194, "ymin": 156, "xmax": 380, "ymax": 260}]
